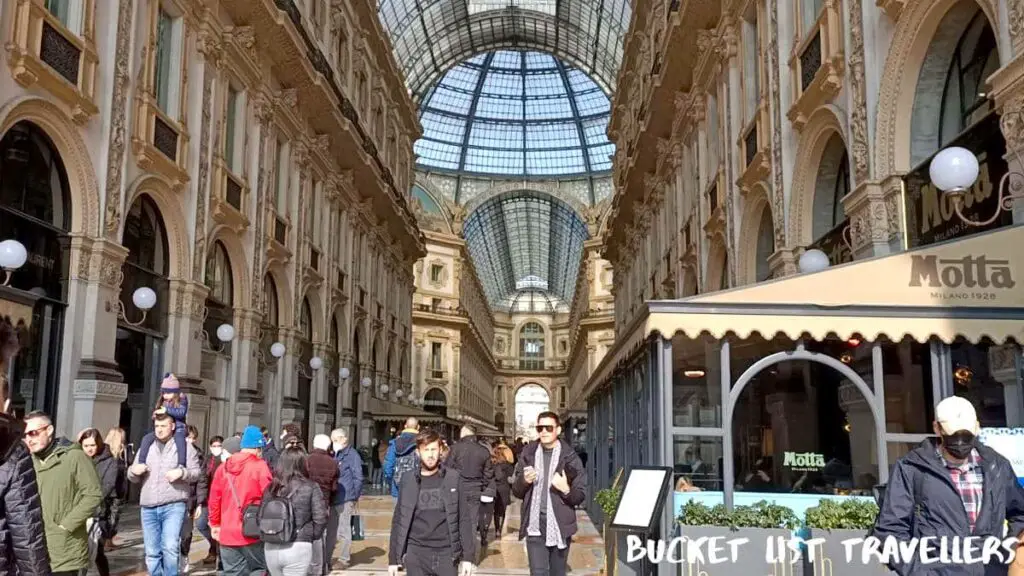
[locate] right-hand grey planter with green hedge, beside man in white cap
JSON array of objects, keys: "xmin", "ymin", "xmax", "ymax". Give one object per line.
[{"xmin": 804, "ymin": 498, "xmax": 889, "ymax": 576}]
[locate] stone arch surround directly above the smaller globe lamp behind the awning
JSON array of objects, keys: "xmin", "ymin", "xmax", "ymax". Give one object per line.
[{"xmin": 787, "ymin": 106, "xmax": 850, "ymax": 246}]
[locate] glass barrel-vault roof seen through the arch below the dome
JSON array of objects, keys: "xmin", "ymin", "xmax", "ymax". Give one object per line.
[{"xmin": 464, "ymin": 189, "xmax": 589, "ymax": 312}]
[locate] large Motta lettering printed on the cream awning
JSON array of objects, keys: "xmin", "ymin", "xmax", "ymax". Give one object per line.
[{"xmin": 910, "ymin": 255, "xmax": 1017, "ymax": 289}]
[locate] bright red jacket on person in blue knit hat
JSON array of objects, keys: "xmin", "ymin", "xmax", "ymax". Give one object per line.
[{"xmin": 208, "ymin": 452, "xmax": 271, "ymax": 546}]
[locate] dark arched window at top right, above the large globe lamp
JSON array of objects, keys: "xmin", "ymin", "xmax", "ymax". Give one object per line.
[{"xmin": 938, "ymin": 9, "xmax": 999, "ymax": 148}]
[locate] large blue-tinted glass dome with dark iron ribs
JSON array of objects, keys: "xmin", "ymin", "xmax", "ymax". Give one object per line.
[{"xmin": 415, "ymin": 50, "xmax": 614, "ymax": 177}]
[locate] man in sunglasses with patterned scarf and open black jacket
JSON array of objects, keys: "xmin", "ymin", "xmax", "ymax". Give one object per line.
[{"xmin": 512, "ymin": 412, "xmax": 587, "ymax": 576}]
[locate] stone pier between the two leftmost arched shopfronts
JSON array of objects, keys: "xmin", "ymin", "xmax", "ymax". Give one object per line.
[{"xmin": 65, "ymin": 236, "xmax": 128, "ymax": 436}]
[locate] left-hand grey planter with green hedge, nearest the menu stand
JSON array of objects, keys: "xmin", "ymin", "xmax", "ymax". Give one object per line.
[{"xmin": 671, "ymin": 500, "xmax": 802, "ymax": 576}]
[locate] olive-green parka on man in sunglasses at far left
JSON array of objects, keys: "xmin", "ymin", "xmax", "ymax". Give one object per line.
[{"xmin": 32, "ymin": 439, "xmax": 103, "ymax": 572}]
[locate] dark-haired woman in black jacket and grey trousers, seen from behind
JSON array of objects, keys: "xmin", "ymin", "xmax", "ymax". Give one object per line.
[{"xmin": 261, "ymin": 447, "xmax": 328, "ymax": 576}]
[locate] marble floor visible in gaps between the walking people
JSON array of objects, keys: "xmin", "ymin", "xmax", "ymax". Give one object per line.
[{"xmin": 89, "ymin": 495, "xmax": 604, "ymax": 576}]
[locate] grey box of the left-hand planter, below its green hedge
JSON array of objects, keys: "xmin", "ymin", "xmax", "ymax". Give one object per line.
[{"xmin": 675, "ymin": 526, "xmax": 804, "ymax": 576}]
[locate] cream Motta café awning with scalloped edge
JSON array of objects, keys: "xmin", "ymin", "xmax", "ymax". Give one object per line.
[{"xmin": 587, "ymin": 225, "xmax": 1024, "ymax": 399}]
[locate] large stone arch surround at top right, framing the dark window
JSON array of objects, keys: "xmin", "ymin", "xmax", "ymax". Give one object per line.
[{"xmin": 872, "ymin": 0, "xmax": 1008, "ymax": 178}]
